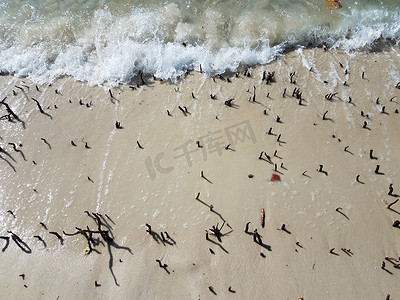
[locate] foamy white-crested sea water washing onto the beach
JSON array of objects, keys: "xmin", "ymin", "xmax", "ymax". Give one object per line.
[{"xmin": 0, "ymin": 0, "xmax": 400, "ymax": 85}]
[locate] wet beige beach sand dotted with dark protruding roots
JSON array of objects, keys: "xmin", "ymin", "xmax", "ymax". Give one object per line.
[{"xmin": 0, "ymin": 48, "xmax": 400, "ymax": 300}]
